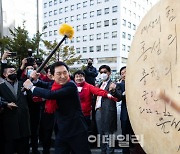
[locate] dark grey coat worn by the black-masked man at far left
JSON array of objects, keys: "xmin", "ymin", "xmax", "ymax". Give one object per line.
[{"xmin": 0, "ymin": 81, "xmax": 30, "ymax": 140}]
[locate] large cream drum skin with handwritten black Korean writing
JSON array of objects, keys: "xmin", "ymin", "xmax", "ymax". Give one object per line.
[{"xmin": 126, "ymin": 0, "xmax": 180, "ymax": 154}]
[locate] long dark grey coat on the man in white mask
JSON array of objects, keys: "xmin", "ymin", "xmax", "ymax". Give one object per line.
[{"xmin": 101, "ymin": 80, "xmax": 121, "ymax": 133}]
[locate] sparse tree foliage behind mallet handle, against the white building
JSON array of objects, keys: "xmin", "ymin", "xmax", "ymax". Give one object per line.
[{"xmin": 43, "ymin": 41, "xmax": 81, "ymax": 65}]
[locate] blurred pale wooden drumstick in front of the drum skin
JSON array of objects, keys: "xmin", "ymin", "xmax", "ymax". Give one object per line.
[{"xmin": 157, "ymin": 90, "xmax": 180, "ymax": 112}]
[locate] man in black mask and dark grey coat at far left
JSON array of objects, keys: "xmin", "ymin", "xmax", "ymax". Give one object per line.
[{"xmin": 0, "ymin": 65, "xmax": 30, "ymax": 154}]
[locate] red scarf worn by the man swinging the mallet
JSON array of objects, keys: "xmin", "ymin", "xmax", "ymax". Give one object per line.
[{"xmin": 45, "ymin": 81, "xmax": 62, "ymax": 113}]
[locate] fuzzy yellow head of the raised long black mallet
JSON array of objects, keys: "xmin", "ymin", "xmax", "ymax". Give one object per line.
[{"xmin": 59, "ymin": 24, "xmax": 74, "ymax": 39}]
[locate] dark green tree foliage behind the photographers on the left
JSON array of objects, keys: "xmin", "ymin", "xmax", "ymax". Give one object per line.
[{"xmin": 0, "ymin": 23, "xmax": 44, "ymax": 66}]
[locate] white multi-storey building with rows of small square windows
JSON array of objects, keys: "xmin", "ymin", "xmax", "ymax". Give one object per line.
[{"xmin": 43, "ymin": 0, "xmax": 158, "ymax": 72}]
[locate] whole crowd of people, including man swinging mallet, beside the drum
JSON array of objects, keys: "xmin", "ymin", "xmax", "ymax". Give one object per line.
[{"xmin": 0, "ymin": 51, "xmax": 143, "ymax": 154}]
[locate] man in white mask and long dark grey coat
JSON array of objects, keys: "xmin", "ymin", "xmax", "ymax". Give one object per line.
[{"xmin": 95, "ymin": 65, "xmax": 121, "ymax": 154}]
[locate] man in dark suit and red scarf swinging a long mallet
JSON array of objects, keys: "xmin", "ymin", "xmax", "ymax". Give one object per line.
[{"xmin": 24, "ymin": 62, "xmax": 91, "ymax": 154}]
